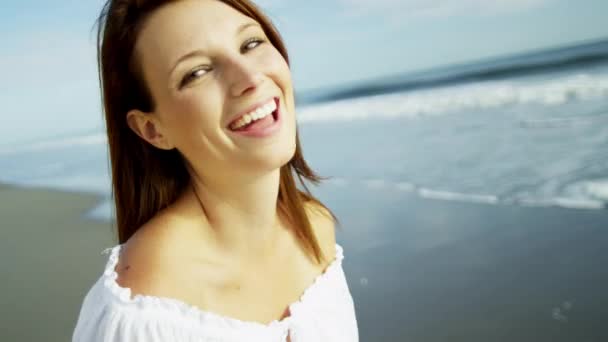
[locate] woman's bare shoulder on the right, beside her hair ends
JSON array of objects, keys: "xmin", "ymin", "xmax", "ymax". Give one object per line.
[{"xmin": 305, "ymin": 201, "xmax": 336, "ymax": 261}]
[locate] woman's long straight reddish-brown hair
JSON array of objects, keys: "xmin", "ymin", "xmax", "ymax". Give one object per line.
[{"xmin": 97, "ymin": 0, "xmax": 338, "ymax": 263}]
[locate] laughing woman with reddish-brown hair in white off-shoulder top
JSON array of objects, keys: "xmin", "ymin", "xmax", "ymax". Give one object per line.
[{"xmin": 73, "ymin": 0, "xmax": 358, "ymax": 342}]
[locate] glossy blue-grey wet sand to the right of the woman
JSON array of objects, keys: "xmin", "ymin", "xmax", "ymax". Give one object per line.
[{"xmin": 320, "ymin": 184, "xmax": 608, "ymax": 342}]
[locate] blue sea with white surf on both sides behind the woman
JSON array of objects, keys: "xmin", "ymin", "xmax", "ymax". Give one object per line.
[{"xmin": 0, "ymin": 41, "xmax": 608, "ymax": 218}]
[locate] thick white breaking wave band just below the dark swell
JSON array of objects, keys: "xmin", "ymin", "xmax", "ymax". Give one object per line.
[{"xmin": 298, "ymin": 73, "xmax": 608, "ymax": 122}]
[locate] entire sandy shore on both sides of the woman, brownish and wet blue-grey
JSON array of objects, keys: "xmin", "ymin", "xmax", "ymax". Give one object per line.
[{"xmin": 0, "ymin": 182, "xmax": 608, "ymax": 342}]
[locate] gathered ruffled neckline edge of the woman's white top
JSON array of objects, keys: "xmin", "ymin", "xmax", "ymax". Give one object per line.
[{"xmin": 102, "ymin": 243, "xmax": 344, "ymax": 328}]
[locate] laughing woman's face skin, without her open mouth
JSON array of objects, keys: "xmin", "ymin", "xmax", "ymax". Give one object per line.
[{"xmin": 129, "ymin": 0, "xmax": 296, "ymax": 180}]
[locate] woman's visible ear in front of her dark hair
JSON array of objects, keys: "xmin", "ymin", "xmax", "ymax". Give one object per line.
[{"xmin": 127, "ymin": 109, "xmax": 175, "ymax": 150}]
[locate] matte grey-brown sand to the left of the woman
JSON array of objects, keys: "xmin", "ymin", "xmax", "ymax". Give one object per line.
[{"xmin": 0, "ymin": 185, "xmax": 114, "ymax": 342}]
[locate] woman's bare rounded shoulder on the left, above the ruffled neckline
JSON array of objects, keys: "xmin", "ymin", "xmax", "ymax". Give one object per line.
[{"xmin": 115, "ymin": 211, "xmax": 192, "ymax": 296}]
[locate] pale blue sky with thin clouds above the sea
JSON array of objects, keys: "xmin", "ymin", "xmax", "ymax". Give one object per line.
[{"xmin": 0, "ymin": 0, "xmax": 608, "ymax": 146}]
